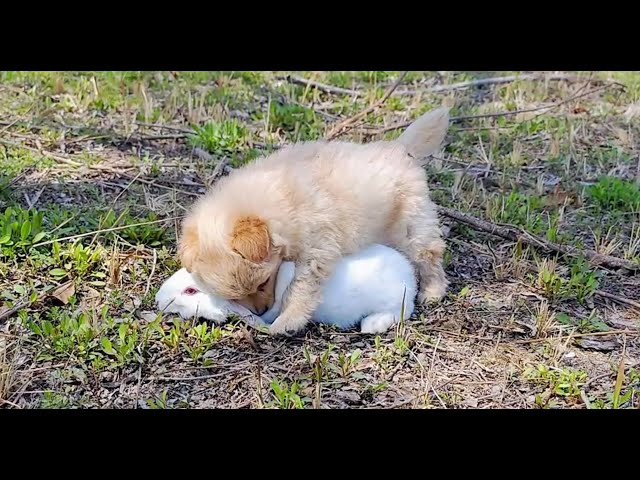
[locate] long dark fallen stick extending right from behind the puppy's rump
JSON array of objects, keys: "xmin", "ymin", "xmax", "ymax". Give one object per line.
[{"xmin": 438, "ymin": 207, "xmax": 640, "ymax": 271}]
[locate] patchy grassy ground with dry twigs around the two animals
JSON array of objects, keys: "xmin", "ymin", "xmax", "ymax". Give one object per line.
[{"xmin": 0, "ymin": 71, "xmax": 640, "ymax": 409}]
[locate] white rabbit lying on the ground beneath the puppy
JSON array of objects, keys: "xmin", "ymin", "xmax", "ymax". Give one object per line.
[{"xmin": 156, "ymin": 245, "xmax": 417, "ymax": 333}]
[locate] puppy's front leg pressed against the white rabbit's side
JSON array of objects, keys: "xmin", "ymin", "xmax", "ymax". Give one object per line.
[{"xmin": 269, "ymin": 260, "xmax": 328, "ymax": 335}]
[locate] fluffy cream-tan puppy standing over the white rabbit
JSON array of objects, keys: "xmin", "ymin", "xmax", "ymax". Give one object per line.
[{"xmin": 179, "ymin": 108, "xmax": 449, "ymax": 334}]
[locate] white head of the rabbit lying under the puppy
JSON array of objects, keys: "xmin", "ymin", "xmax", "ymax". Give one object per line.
[{"xmin": 156, "ymin": 268, "xmax": 253, "ymax": 323}]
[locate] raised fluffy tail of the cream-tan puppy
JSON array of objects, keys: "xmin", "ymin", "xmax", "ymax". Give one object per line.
[{"xmin": 397, "ymin": 107, "xmax": 449, "ymax": 163}]
